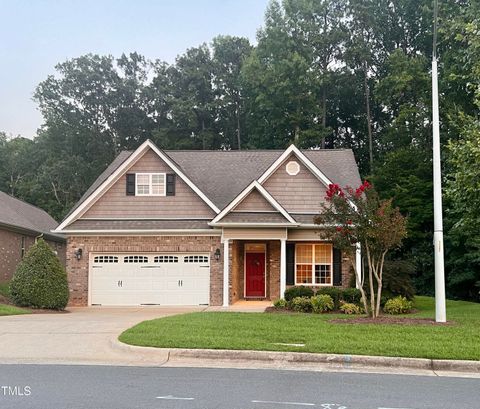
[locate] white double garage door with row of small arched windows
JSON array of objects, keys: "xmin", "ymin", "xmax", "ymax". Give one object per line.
[{"xmin": 90, "ymin": 253, "xmax": 210, "ymax": 305}]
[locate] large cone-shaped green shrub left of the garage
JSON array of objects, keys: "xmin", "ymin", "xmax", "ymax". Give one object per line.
[{"xmin": 10, "ymin": 239, "xmax": 69, "ymax": 310}]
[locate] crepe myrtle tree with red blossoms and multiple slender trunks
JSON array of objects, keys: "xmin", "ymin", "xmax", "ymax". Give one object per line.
[{"xmin": 315, "ymin": 181, "xmax": 407, "ymax": 318}]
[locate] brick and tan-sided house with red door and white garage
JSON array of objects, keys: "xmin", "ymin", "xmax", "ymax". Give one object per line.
[{"xmin": 54, "ymin": 141, "xmax": 360, "ymax": 306}]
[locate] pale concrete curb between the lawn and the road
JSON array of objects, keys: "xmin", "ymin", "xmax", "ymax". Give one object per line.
[{"xmin": 113, "ymin": 340, "xmax": 480, "ymax": 374}]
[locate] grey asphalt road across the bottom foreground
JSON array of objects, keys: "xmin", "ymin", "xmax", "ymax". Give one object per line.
[{"xmin": 0, "ymin": 365, "xmax": 480, "ymax": 409}]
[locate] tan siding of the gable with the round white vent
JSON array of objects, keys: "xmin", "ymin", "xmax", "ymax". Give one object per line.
[{"xmin": 263, "ymin": 155, "xmax": 327, "ymax": 213}]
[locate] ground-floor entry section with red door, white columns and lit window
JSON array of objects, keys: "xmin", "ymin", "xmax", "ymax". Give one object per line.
[{"xmin": 222, "ymin": 229, "xmax": 359, "ymax": 307}]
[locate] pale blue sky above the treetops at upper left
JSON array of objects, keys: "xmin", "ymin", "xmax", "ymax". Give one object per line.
[{"xmin": 0, "ymin": 0, "xmax": 268, "ymax": 138}]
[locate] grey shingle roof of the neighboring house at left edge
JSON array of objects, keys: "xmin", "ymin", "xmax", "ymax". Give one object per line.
[{"xmin": 0, "ymin": 192, "xmax": 64, "ymax": 241}]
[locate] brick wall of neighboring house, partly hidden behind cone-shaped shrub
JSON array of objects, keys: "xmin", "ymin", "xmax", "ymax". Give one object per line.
[{"xmin": 0, "ymin": 229, "xmax": 65, "ymax": 282}]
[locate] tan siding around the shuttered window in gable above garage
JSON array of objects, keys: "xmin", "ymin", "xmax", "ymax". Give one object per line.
[{"xmin": 82, "ymin": 150, "xmax": 215, "ymax": 218}]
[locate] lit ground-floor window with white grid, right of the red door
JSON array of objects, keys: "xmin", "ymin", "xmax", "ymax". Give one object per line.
[{"xmin": 295, "ymin": 243, "xmax": 333, "ymax": 285}]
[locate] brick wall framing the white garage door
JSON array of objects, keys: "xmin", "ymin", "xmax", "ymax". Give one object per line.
[{"xmin": 67, "ymin": 236, "xmax": 223, "ymax": 306}]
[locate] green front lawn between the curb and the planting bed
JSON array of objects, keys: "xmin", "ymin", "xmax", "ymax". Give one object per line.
[{"xmin": 119, "ymin": 297, "xmax": 480, "ymax": 360}]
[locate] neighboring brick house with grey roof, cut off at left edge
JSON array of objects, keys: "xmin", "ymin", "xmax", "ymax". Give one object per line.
[{"xmin": 0, "ymin": 192, "xmax": 66, "ymax": 282}]
